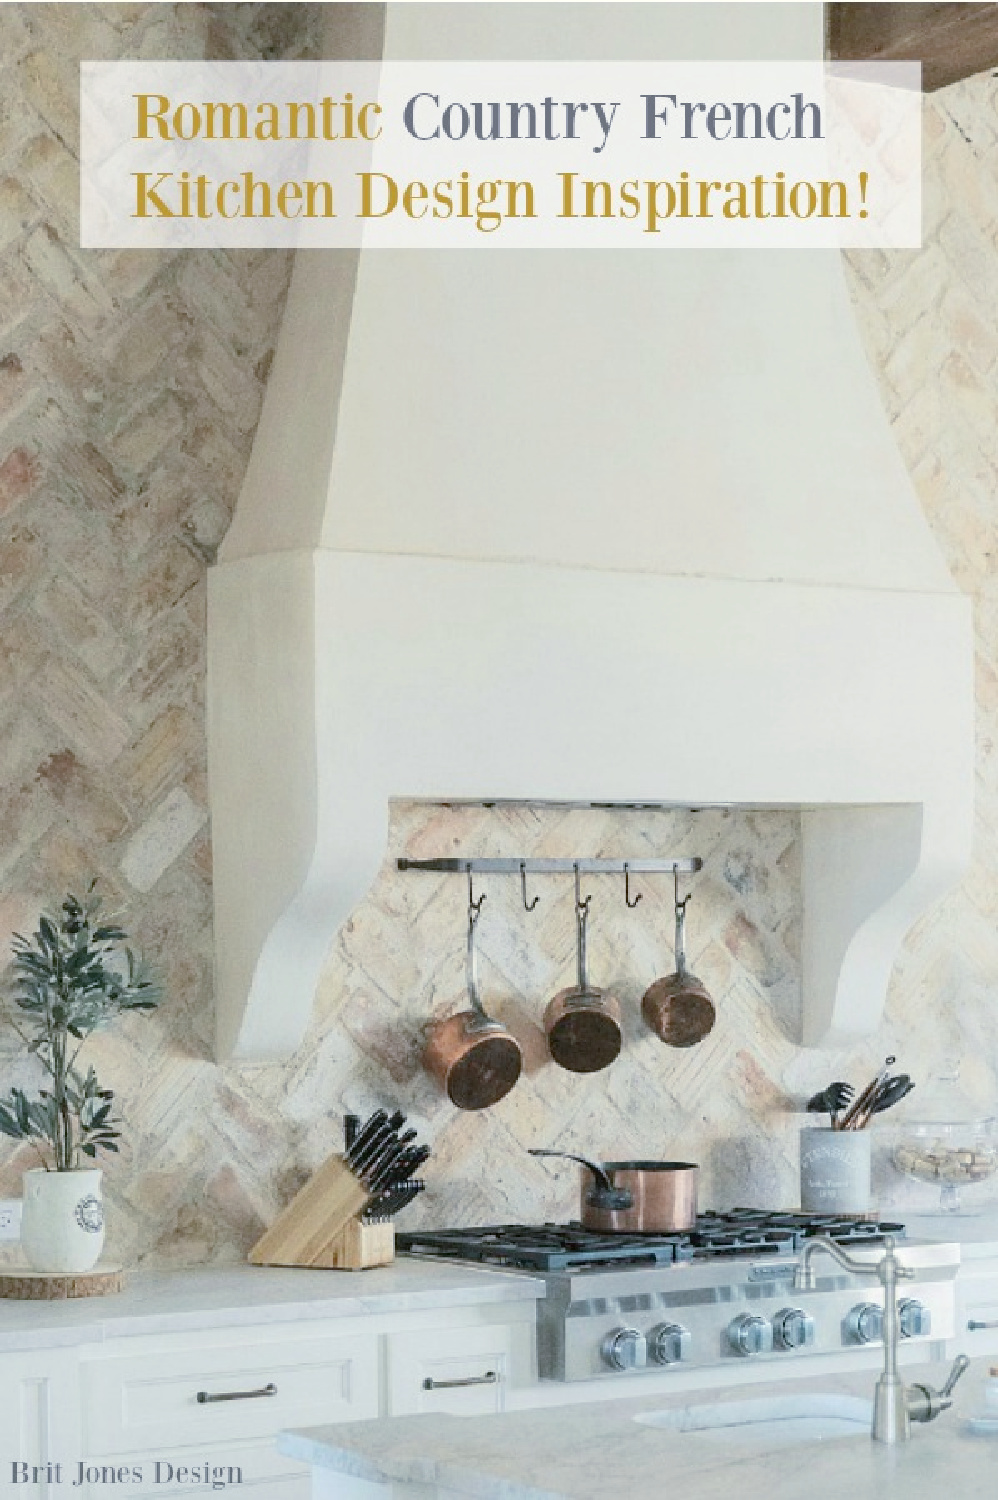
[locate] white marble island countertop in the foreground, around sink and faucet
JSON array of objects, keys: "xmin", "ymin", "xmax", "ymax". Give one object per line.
[{"xmin": 278, "ymin": 1359, "xmax": 998, "ymax": 1500}]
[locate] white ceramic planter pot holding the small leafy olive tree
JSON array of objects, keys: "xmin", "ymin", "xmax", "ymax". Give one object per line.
[{"xmin": 21, "ymin": 1167, "xmax": 104, "ymax": 1274}]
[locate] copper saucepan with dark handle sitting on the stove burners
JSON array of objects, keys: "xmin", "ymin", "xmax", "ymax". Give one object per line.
[{"xmin": 530, "ymin": 1151, "xmax": 699, "ymax": 1235}]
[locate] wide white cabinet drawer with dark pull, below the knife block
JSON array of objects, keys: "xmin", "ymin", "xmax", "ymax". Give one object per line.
[{"xmin": 81, "ymin": 1331, "xmax": 378, "ymax": 1458}]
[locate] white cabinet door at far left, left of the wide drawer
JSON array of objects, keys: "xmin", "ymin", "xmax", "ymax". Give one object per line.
[{"xmin": 0, "ymin": 1349, "xmax": 80, "ymax": 1500}]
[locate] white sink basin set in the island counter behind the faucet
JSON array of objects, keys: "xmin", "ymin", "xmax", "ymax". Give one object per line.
[{"xmin": 635, "ymin": 1392, "xmax": 873, "ymax": 1448}]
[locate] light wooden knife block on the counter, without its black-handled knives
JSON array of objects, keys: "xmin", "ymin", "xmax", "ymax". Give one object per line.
[{"xmin": 249, "ymin": 1157, "xmax": 395, "ymax": 1271}]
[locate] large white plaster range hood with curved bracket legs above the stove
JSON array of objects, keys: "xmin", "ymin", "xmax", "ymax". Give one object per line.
[{"xmin": 209, "ymin": 5, "xmax": 972, "ymax": 1061}]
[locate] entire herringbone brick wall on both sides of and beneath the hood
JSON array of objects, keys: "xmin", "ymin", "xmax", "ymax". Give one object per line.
[{"xmin": 0, "ymin": 20, "xmax": 998, "ymax": 1265}]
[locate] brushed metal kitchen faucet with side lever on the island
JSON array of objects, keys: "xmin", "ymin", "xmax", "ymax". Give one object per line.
[{"xmin": 794, "ymin": 1235, "xmax": 969, "ymax": 1443}]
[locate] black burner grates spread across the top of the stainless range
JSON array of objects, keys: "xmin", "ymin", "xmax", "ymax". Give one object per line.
[{"xmin": 395, "ymin": 1209, "xmax": 905, "ymax": 1271}]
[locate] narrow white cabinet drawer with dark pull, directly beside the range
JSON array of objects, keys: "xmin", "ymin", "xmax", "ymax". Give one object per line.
[{"xmin": 387, "ymin": 1326, "xmax": 512, "ymax": 1416}]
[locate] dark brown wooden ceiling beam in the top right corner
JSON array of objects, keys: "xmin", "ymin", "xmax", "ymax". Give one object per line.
[{"xmin": 825, "ymin": 0, "xmax": 998, "ymax": 93}]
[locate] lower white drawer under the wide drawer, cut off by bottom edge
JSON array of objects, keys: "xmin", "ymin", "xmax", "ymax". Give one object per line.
[{"xmin": 73, "ymin": 1442, "xmax": 309, "ymax": 1500}]
